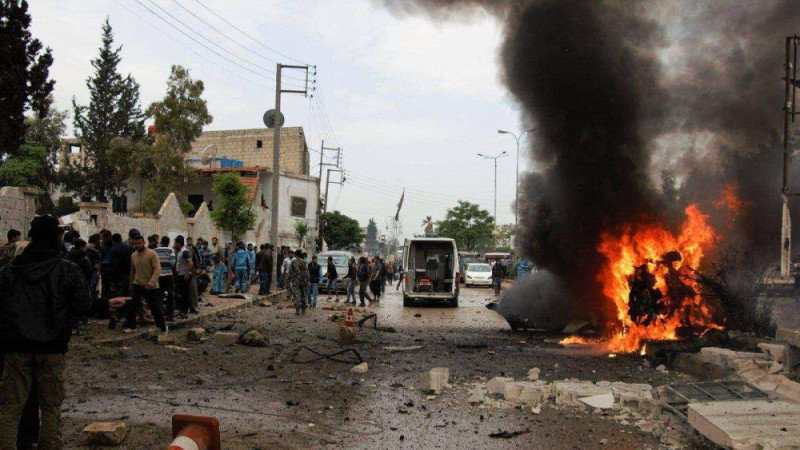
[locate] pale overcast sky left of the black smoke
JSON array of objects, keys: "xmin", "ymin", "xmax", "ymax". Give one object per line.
[{"xmin": 30, "ymin": 0, "xmax": 527, "ymax": 241}]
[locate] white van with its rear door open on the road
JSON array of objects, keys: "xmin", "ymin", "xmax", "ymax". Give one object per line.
[{"xmin": 402, "ymin": 237, "xmax": 460, "ymax": 306}]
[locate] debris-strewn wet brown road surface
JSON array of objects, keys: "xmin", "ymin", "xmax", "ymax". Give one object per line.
[{"xmin": 64, "ymin": 288, "xmax": 679, "ymax": 449}]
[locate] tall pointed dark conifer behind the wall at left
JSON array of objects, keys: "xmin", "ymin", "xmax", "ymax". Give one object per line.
[{"xmin": 64, "ymin": 19, "xmax": 144, "ymax": 201}]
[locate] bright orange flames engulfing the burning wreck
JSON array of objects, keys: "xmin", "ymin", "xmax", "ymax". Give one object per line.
[{"xmin": 597, "ymin": 204, "xmax": 721, "ymax": 353}]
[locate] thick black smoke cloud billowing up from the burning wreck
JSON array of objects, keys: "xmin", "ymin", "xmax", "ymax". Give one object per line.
[{"xmin": 384, "ymin": 0, "xmax": 800, "ymax": 324}]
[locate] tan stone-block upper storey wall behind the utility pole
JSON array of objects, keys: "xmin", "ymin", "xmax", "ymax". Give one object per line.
[{"xmin": 191, "ymin": 127, "xmax": 309, "ymax": 175}]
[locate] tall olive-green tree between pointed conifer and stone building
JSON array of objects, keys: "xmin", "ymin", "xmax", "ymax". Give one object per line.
[{"xmin": 111, "ymin": 66, "xmax": 213, "ymax": 212}]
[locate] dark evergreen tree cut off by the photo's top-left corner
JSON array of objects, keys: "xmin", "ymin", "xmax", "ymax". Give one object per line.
[{"xmin": 0, "ymin": 0, "xmax": 55, "ymax": 158}]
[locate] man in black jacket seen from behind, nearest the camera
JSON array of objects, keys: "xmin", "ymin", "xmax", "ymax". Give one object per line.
[{"xmin": 0, "ymin": 216, "xmax": 91, "ymax": 449}]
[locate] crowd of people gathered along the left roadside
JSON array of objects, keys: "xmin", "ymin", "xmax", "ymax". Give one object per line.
[{"xmin": 0, "ymin": 216, "xmax": 399, "ymax": 449}]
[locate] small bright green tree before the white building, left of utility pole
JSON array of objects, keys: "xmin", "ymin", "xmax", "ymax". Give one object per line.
[{"xmin": 211, "ymin": 172, "xmax": 256, "ymax": 239}]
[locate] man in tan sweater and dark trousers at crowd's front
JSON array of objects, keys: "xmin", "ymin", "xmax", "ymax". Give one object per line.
[{"xmin": 125, "ymin": 235, "xmax": 167, "ymax": 332}]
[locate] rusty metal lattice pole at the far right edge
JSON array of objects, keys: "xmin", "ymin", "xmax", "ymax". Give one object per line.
[{"xmin": 781, "ymin": 36, "xmax": 800, "ymax": 279}]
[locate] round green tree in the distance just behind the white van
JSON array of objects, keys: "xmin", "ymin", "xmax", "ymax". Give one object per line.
[{"xmin": 438, "ymin": 200, "xmax": 494, "ymax": 251}]
